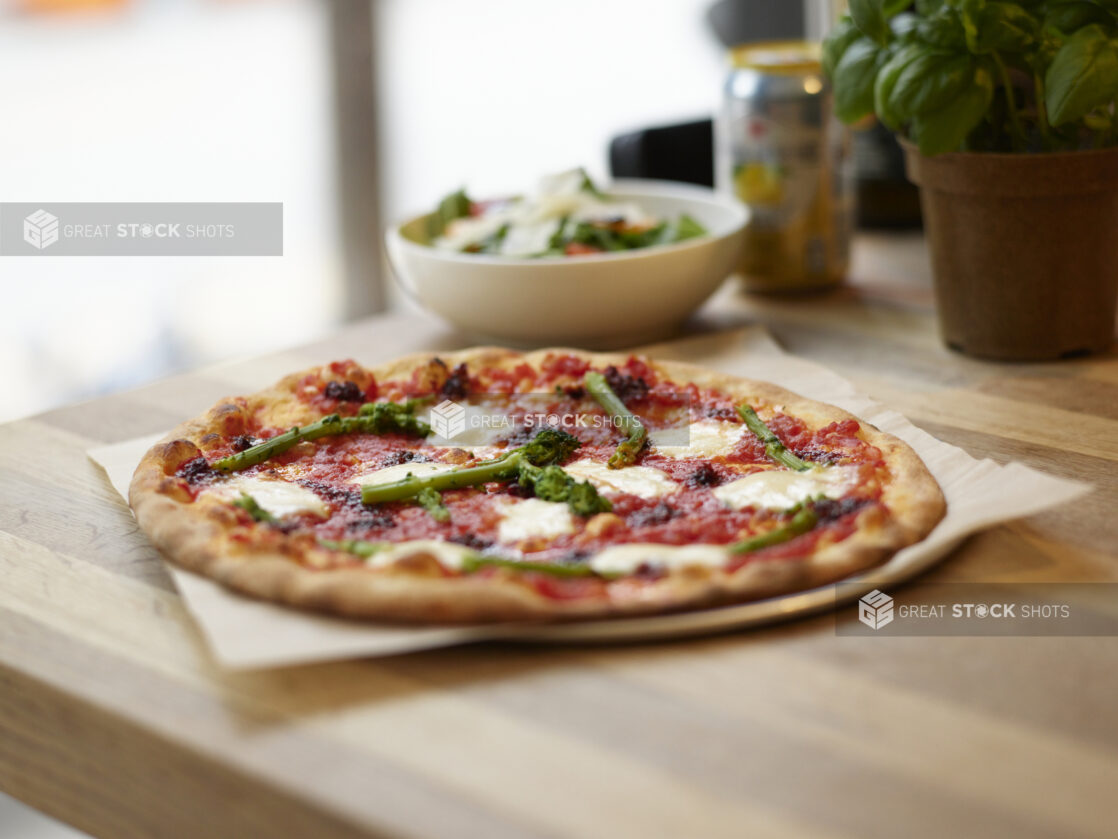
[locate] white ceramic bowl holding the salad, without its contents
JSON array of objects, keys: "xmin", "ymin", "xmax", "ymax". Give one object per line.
[{"xmin": 387, "ymin": 180, "xmax": 748, "ymax": 348}]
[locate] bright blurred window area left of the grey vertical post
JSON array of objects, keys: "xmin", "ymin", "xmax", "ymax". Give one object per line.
[{"xmin": 0, "ymin": 2, "xmax": 341, "ymax": 420}]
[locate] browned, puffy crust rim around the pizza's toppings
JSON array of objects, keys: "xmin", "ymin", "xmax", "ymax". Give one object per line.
[{"xmin": 129, "ymin": 347, "xmax": 946, "ymax": 623}]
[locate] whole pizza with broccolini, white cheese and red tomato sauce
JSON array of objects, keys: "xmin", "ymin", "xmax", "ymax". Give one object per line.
[{"xmin": 130, "ymin": 348, "xmax": 945, "ymax": 623}]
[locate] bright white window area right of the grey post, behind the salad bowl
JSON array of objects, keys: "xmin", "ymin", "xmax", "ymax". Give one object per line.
[{"xmin": 377, "ymin": 0, "xmax": 726, "ymax": 219}]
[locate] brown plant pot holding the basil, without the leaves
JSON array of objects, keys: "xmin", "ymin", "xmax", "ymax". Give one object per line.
[{"xmin": 903, "ymin": 142, "xmax": 1118, "ymax": 361}]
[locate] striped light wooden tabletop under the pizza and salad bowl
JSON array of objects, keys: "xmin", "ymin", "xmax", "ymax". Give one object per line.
[{"xmin": 0, "ymin": 238, "xmax": 1118, "ymax": 839}]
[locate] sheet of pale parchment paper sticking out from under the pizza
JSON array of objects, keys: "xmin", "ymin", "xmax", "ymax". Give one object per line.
[{"xmin": 88, "ymin": 327, "xmax": 1091, "ymax": 669}]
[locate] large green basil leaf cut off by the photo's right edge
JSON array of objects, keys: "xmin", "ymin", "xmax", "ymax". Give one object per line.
[{"xmin": 1044, "ymin": 23, "xmax": 1118, "ymax": 125}]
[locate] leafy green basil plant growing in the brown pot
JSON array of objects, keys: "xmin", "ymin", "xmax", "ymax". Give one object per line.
[{"xmin": 823, "ymin": 0, "xmax": 1118, "ymax": 154}]
